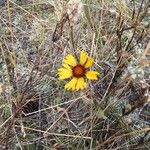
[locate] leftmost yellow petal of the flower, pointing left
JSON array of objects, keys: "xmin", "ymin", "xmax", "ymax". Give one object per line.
[{"xmin": 58, "ymin": 68, "xmax": 72, "ymax": 80}]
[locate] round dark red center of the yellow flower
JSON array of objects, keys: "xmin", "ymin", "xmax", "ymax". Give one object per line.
[{"xmin": 72, "ymin": 64, "xmax": 86, "ymax": 78}]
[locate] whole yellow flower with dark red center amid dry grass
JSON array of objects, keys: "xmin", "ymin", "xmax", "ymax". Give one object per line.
[{"xmin": 58, "ymin": 50, "xmax": 99, "ymax": 91}]
